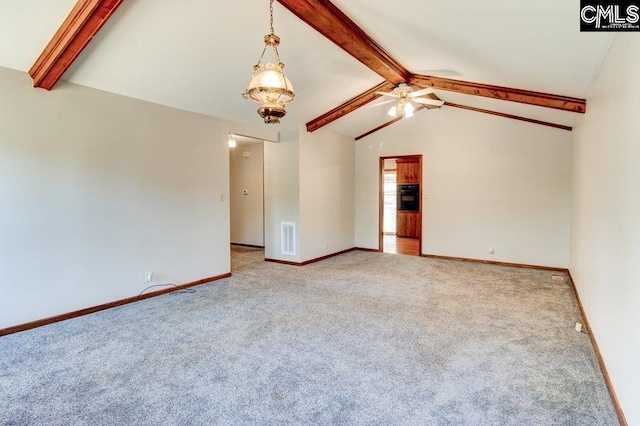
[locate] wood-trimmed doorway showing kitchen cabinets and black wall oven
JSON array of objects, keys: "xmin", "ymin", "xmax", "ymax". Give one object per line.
[{"xmin": 379, "ymin": 155, "xmax": 422, "ymax": 256}]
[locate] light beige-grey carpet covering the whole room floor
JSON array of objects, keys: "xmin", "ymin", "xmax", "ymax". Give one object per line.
[{"xmin": 0, "ymin": 248, "xmax": 617, "ymax": 425}]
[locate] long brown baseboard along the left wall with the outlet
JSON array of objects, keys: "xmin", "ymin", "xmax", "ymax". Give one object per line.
[{"xmin": 0, "ymin": 272, "xmax": 231, "ymax": 337}]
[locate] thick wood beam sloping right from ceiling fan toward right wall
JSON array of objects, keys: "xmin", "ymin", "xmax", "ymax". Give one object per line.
[{"xmin": 410, "ymin": 74, "xmax": 587, "ymax": 114}]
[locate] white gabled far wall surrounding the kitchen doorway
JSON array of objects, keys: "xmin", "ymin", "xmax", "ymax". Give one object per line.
[{"xmin": 355, "ymin": 107, "xmax": 572, "ymax": 267}]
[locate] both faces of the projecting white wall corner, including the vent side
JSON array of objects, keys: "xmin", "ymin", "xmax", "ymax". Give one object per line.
[{"xmin": 265, "ymin": 124, "xmax": 355, "ymax": 262}]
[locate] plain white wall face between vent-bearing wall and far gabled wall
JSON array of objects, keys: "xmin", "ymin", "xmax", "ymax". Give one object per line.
[{"xmin": 300, "ymin": 127, "xmax": 355, "ymax": 261}]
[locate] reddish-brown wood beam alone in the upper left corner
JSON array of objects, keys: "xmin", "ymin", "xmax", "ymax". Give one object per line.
[{"xmin": 29, "ymin": 0, "xmax": 123, "ymax": 90}]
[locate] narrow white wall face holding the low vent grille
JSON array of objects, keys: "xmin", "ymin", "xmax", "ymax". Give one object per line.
[{"xmin": 264, "ymin": 124, "xmax": 300, "ymax": 262}]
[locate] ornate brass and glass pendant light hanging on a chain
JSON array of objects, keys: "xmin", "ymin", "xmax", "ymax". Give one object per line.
[{"xmin": 242, "ymin": 0, "xmax": 295, "ymax": 124}]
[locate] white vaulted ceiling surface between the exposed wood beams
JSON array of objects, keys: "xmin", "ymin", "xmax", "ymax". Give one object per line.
[{"xmin": 0, "ymin": 0, "xmax": 615, "ymax": 137}]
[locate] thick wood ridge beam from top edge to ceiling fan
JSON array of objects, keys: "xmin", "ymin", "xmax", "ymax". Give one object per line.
[{"xmin": 278, "ymin": 0, "xmax": 410, "ymax": 84}]
